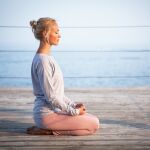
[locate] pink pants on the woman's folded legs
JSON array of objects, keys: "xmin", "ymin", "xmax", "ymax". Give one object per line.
[{"xmin": 42, "ymin": 113, "xmax": 99, "ymax": 135}]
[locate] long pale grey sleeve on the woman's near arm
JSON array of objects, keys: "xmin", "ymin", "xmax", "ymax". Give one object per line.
[{"xmin": 37, "ymin": 59, "xmax": 79, "ymax": 116}]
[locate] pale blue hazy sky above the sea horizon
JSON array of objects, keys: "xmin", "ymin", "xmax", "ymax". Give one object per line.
[{"xmin": 0, "ymin": 0, "xmax": 150, "ymax": 51}]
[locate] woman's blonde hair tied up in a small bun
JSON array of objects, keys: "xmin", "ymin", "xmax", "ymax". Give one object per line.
[{"xmin": 30, "ymin": 17, "xmax": 57, "ymax": 40}]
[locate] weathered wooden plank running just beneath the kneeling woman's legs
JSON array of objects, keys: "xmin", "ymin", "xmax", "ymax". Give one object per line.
[{"xmin": 0, "ymin": 133, "xmax": 150, "ymax": 142}]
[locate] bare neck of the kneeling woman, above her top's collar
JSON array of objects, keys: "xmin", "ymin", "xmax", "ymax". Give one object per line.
[{"xmin": 37, "ymin": 41, "xmax": 52, "ymax": 54}]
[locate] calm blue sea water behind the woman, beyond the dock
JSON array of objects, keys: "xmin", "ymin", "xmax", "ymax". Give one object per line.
[{"xmin": 0, "ymin": 52, "xmax": 150, "ymax": 87}]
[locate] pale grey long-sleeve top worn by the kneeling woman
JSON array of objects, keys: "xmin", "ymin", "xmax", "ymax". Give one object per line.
[{"xmin": 31, "ymin": 53, "xmax": 79, "ymax": 117}]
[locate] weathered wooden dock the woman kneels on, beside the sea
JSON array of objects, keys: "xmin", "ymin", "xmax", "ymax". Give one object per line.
[{"xmin": 0, "ymin": 87, "xmax": 150, "ymax": 150}]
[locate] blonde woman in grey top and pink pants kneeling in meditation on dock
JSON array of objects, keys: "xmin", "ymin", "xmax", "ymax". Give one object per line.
[{"xmin": 27, "ymin": 18, "xmax": 99, "ymax": 135}]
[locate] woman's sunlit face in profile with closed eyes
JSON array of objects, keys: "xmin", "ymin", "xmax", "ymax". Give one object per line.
[{"xmin": 49, "ymin": 24, "xmax": 60, "ymax": 45}]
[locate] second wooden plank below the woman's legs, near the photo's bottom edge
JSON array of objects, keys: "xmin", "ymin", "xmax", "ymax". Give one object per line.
[{"xmin": 0, "ymin": 139, "xmax": 150, "ymax": 147}]
